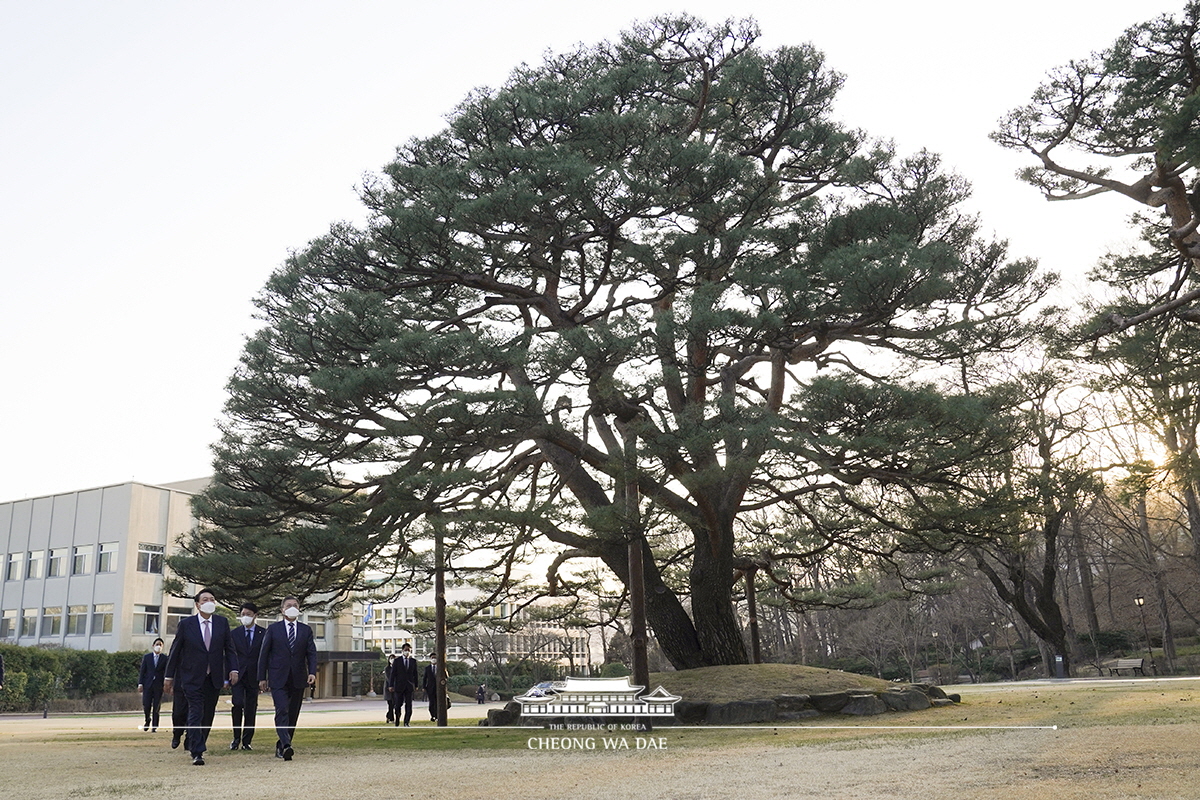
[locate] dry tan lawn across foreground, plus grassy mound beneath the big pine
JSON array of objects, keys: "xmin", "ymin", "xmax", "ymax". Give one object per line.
[{"xmin": 9, "ymin": 664, "xmax": 1200, "ymax": 800}]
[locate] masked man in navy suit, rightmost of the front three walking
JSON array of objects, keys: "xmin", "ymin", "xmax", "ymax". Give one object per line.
[{"xmin": 258, "ymin": 597, "xmax": 317, "ymax": 762}]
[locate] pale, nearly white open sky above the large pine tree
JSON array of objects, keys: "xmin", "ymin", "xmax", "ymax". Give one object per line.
[{"xmin": 0, "ymin": 0, "xmax": 1183, "ymax": 501}]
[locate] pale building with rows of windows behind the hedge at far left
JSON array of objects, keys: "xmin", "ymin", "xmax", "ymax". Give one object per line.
[{"xmin": 0, "ymin": 477, "xmax": 373, "ymax": 696}]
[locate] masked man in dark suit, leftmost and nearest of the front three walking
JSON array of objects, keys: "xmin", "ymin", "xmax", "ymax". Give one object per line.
[{"xmin": 164, "ymin": 589, "xmax": 238, "ymax": 766}]
